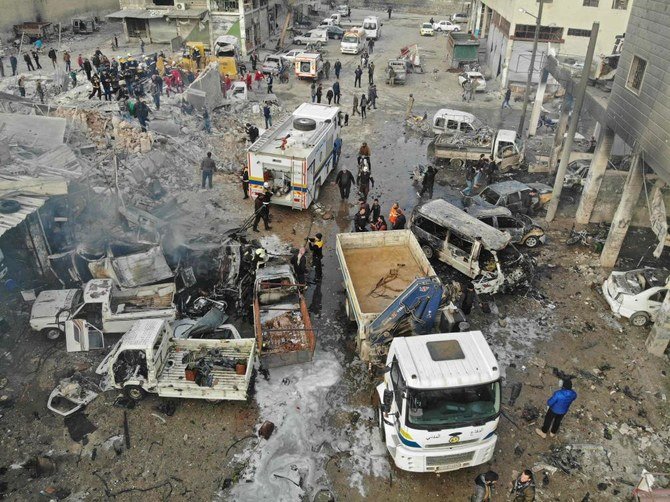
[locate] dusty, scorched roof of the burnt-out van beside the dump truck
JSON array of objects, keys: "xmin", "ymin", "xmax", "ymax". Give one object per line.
[{"xmin": 417, "ymin": 199, "xmax": 512, "ymax": 251}]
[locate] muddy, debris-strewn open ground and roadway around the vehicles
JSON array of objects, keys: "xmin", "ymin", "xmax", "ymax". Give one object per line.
[{"xmin": 0, "ymin": 4, "xmax": 670, "ymax": 501}]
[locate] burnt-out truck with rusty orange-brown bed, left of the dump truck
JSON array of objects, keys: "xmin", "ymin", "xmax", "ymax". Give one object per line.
[{"xmin": 253, "ymin": 264, "xmax": 316, "ymax": 368}]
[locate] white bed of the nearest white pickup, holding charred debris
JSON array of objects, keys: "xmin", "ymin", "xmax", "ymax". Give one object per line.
[{"xmin": 158, "ymin": 338, "xmax": 255, "ymax": 401}]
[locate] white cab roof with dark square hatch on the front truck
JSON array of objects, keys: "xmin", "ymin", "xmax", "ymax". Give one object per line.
[{"xmin": 392, "ymin": 331, "xmax": 500, "ymax": 389}]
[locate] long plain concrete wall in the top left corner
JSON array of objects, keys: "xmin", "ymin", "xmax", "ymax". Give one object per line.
[{"xmin": 0, "ymin": 0, "xmax": 119, "ymax": 33}]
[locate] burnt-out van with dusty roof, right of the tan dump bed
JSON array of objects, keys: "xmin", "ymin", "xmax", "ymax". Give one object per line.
[{"xmin": 410, "ymin": 199, "xmax": 532, "ymax": 294}]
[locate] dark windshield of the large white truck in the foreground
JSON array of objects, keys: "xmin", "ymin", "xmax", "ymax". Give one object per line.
[{"xmin": 407, "ymin": 381, "xmax": 500, "ymax": 428}]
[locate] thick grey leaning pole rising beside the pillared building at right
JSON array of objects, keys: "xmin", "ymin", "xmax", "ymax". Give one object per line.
[{"xmin": 546, "ymin": 22, "xmax": 600, "ymax": 222}]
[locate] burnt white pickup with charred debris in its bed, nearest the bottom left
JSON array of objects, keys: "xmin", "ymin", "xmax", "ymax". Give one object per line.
[{"xmin": 95, "ymin": 319, "xmax": 256, "ymax": 401}]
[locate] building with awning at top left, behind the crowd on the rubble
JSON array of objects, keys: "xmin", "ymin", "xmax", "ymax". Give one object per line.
[{"xmin": 107, "ymin": 0, "xmax": 296, "ymax": 55}]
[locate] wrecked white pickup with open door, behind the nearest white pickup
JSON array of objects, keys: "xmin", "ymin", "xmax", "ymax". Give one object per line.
[{"xmin": 30, "ymin": 279, "xmax": 177, "ymax": 340}]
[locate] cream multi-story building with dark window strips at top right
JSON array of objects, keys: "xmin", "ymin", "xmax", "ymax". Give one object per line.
[{"xmin": 468, "ymin": 0, "xmax": 637, "ymax": 86}]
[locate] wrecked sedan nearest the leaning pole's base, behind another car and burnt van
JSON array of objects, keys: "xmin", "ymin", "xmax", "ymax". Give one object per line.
[{"xmin": 472, "ymin": 180, "xmax": 552, "ymax": 214}]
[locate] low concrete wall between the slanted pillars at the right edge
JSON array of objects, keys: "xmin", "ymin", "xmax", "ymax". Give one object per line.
[{"xmin": 591, "ymin": 171, "xmax": 670, "ymax": 227}]
